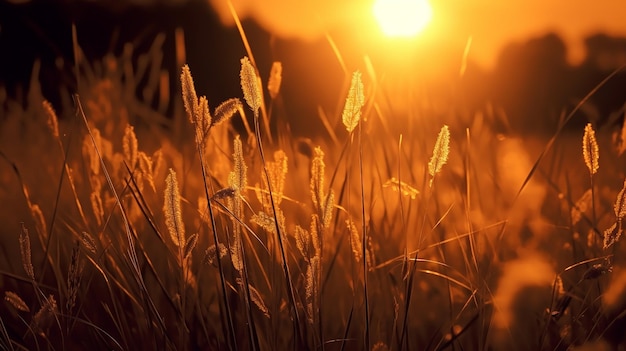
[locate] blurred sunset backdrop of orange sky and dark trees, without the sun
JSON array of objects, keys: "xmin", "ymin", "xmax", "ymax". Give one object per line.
[{"xmin": 0, "ymin": 0, "xmax": 626, "ymax": 133}]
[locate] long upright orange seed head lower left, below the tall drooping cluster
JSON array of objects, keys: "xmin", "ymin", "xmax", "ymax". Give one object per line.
[{"xmin": 163, "ymin": 168, "xmax": 185, "ymax": 247}]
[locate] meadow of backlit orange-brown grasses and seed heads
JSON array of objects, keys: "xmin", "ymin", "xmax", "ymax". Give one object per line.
[{"xmin": 0, "ymin": 23, "xmax": 626, "ymax": 351}]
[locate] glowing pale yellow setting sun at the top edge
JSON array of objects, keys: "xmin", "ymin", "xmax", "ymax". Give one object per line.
[{"xmin": 373, "ymin": 0, "xmax": 433, "ymax": 37}]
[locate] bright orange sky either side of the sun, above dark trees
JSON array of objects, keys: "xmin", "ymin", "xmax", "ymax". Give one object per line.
[{"xmin": 208, "ymin": 0, "xmax": 626, "ymax": 68}]
